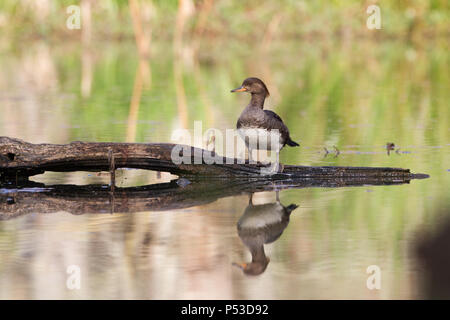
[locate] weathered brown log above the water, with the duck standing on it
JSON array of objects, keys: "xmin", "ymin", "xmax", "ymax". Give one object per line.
[{"xmin": 0, "ymin": 137, "xmax": 427, "ymax": 181}]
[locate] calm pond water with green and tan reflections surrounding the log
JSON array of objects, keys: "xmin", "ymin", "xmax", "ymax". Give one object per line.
[{"xmin": 0, "ymin": 40, "xmax": 450, "ymax": 299}]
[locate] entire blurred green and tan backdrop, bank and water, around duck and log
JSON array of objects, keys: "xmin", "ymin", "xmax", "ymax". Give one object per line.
[{"xmin": 0, "ymin": 0, "xmax": 450, "ymax": 299}]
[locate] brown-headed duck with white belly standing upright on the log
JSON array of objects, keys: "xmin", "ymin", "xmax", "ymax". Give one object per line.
[{"xmin": 231, "ymin": 78, "xmax": 299, "ymax": 165}]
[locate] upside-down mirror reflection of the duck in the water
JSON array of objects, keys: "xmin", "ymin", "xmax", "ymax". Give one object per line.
[{"xmin": 233, "ymin": 192, "xmax": 298, "ymax": 276}]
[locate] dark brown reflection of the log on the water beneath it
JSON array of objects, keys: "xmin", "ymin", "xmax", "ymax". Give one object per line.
[{"xmin": 0, "ymin": 177, "xmax": 409, "ymax": 220}]
